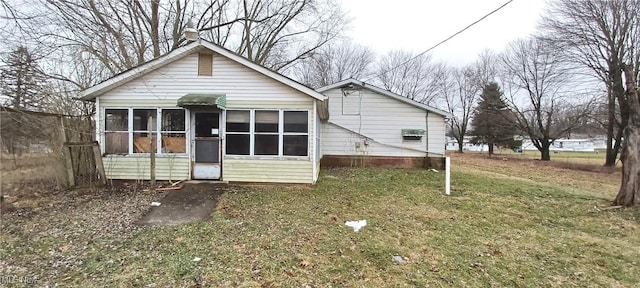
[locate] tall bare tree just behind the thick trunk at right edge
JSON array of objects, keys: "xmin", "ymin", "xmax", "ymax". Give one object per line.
[{"xmin": 542, "ymin": 0, "xmax": 640, "ymax": 166}]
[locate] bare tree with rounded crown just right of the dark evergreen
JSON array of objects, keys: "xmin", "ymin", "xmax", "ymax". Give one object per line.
[{"xmin": 500, "ymin": 38, "xmax": 594, "ymax": 160}]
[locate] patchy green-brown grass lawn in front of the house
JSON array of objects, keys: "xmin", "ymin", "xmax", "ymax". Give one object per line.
[{"xmin": 0, "ymin": 155, "xmax": 640, "ymax": 287}]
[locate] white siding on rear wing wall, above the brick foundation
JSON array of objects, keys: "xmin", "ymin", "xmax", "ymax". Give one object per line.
[{"xmin": 322, "ymin": 89, "xmax": 444, "ymax": 157}]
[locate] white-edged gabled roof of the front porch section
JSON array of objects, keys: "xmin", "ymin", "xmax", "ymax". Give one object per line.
[{"xmin": 80, "ymin": 40, "xmax": 327, "ymax": 101}]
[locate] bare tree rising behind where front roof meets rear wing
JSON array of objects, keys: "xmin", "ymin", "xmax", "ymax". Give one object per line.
[{"xmin": 291, "ymin": 40, "xmax": 376, "ymax": 88}]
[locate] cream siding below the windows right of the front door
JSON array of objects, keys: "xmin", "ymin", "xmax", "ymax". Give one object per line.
[{"xmin": 222, "ymin": 158, "xmax": 313, "ymax": 184}]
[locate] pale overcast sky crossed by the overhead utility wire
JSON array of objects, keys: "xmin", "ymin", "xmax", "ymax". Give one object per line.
[{"xmin": 342, "ymin": 0, "xmax": 545, "ymax": 65}]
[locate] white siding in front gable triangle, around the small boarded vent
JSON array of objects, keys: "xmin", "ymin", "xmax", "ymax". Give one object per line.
[{"xmin": 100, "ymin": 53, "xmax": 313, "ymax": 104}]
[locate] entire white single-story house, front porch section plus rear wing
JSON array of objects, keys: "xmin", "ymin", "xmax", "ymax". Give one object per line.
[{"xmin": 81, "ymin": 40, "xmax": 446, "ymax": 183}]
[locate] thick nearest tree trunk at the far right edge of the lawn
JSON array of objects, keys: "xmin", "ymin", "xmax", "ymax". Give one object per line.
[{"xmin": 614, "ymin": 66, "xmax": 640, "ymax": 206}]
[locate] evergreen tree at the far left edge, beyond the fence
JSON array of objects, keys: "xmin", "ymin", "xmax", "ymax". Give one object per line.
[{"xmin": 0, "ymin": 46, "xmax": 47, "ymax": 111}]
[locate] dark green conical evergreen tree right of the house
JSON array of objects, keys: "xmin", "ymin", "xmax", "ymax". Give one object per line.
[{"xmin": 470, "ymin": 82, "xmax": 518, "ymax": 155}]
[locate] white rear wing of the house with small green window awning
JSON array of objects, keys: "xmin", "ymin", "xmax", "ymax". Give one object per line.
[{"xmin": 317, "ymin": 79, "xmax": 450, "ymax": 168}]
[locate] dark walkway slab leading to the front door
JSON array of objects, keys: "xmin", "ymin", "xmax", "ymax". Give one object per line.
[{"xmin": 138, "ymin": 183, "xmax": 226, "ymax": 225}]
